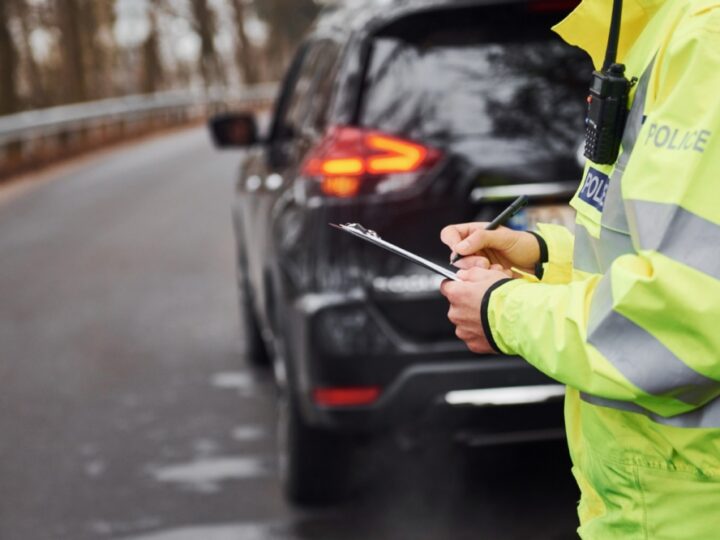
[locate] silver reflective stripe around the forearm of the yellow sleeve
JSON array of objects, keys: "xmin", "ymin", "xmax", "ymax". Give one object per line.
[{"xmin": 588, "ymin": 304, "xmax": 720, "ymax": 405}]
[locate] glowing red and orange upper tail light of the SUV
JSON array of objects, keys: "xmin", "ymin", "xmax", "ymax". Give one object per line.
[{"xmin": 302, "ymin": 126, "xmax": 441, "ymax": 197}]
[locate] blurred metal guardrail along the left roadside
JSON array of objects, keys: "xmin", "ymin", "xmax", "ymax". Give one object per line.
[{"xmin": 0, "ymin": 83, "xmax": 278, "ymax": 176}]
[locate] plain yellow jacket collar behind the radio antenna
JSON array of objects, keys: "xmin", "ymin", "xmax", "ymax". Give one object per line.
[{"xmin": 553, "ymin": 0, "xmax": 665, "ymax": 69}]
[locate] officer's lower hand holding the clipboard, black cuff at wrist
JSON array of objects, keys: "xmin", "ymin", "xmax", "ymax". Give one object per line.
[{"xmin": 440, "ymin": 265, "xmax": 508, "ymax": 353}]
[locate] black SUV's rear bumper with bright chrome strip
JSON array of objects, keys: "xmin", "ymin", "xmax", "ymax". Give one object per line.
[{"xmin": 286, "ymin": 293, "xmax": 564, "ymax": 432}]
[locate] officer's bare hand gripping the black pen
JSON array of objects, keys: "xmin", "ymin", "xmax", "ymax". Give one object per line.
[{"xmin": 440, "ymin": 222, "xmax": 540, "ymax": 273}]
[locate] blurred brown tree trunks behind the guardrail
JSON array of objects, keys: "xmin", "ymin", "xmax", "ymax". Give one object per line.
[{"xmin": 0, "ymin": 0, "xmax": 320, "ymax": 115}]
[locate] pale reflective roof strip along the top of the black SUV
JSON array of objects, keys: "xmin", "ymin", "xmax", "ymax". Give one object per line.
[{"xmin": 312, "ymin": 0, "xmax": 522, "ymax": 37}]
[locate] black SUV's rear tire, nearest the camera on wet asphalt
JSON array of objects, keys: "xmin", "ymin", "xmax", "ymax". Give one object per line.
[{"xmin": 278, "ymin": 392, "xmax": 356, "ymax": 506}]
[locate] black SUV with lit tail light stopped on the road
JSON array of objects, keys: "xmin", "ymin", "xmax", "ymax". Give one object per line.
[{"xmin": 211, "ymin": 0, "xmax": 591, "ymax": 503}]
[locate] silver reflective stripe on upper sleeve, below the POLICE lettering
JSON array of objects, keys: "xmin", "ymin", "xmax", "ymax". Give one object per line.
[{"xmin": 627, "ymin": 200, "xmax": 720, "ymax": 279}]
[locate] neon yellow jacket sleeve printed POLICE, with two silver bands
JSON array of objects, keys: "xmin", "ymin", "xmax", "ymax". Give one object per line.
[{"xmin": 483, "ymin": 9, "xmax": 720, "ymax": 417}]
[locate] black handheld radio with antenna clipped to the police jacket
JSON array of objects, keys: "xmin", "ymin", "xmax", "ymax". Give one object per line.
[{"xmin": 584, "ymin": 0, "xmax": 636, "ymax": 165}]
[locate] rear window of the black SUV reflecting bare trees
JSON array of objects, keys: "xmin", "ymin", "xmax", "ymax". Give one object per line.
[{"xmin": 361, "ymin": 5, "xmax": 592, "ymax": 168}]
